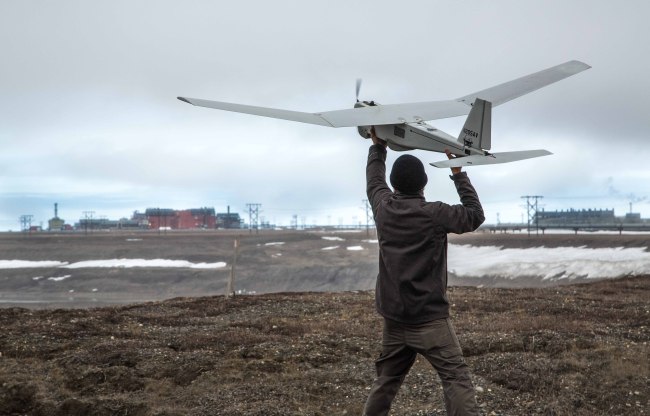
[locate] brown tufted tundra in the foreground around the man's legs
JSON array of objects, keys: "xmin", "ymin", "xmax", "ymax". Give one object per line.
[{"xmin": 0, "ymin": 276, "xmax": 650, "ymax": 416}]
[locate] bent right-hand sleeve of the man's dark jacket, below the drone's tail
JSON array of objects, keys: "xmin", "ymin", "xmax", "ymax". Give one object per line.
[{"xmin": 443, "ymin": 172, "xmax": 485, "ymax": 234}]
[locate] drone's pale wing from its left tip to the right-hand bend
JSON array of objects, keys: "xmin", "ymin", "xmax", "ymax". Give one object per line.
[{"xmin": 178, "ymin": 97, "xmax": 470, "ymax": 127}]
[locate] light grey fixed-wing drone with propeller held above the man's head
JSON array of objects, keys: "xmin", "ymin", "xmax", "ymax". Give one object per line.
[{"xmin": 178, "ymin": 61, "xmax": 591, "ymax": 168}]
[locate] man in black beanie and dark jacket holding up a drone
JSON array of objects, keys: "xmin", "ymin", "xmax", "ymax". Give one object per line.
[{"xmin": 364, "ymin": 127, "xmax": 485, "ymax": 416}]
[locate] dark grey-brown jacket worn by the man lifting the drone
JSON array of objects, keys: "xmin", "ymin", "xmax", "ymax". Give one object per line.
[{"xmin": 366, "ymin": 145, "xmax": 485, "ymax": 324}]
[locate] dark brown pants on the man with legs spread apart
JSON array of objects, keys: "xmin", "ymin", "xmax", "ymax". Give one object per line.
[{"xmin": 364, "ymin": 319, "xmax": 478, "ymax": 416}]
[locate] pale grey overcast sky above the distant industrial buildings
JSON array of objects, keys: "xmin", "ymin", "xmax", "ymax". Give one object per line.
[{"xmin": 0, "ymin": 0, "xmax": 650, "ymax": 230}]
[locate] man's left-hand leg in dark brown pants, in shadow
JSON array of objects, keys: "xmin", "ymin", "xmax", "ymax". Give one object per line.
[{"xmin": 363, "ymin": 320, "xmax": 416, "ymax": 416}]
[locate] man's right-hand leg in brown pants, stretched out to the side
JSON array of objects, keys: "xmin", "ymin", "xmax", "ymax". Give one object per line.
[{"xmin": 418, "ymin": 319, "xmax": 478, "ymax": 415}]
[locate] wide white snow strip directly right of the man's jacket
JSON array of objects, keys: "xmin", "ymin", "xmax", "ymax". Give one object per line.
[{"xmin": 447, "ymin": 244, "xmax": 650, "ymax": 280}]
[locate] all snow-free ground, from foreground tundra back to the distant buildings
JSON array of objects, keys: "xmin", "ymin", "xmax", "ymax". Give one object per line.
[{"xmin": 0, "ymin": 229, "xmax": 650, "ymax": 416}]
